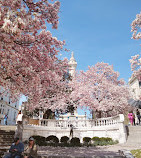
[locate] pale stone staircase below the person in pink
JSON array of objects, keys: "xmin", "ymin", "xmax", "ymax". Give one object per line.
[{"xmin": 126, "ymin": 126, "xmax": 141, "ymax": 147}]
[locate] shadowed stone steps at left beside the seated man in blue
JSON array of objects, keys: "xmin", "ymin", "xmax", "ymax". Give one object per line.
[{"xmin": 0, "ymin": 126, "xmax": 15, "ymax": 158}]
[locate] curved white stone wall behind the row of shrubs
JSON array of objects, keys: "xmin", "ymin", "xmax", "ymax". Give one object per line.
[{"xmin": 23, "ymin": 115, "xmax": 127, "ymax": 143}]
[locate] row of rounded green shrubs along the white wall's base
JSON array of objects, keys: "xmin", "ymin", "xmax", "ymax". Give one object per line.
[{"xmin": 32, "ymin": 135, "xmax": 118, "ymax": 147}]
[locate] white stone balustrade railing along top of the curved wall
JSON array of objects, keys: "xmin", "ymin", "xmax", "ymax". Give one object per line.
[{"xmin": 39, "ymin": 115, "xmax": 120, "ymax": 128}]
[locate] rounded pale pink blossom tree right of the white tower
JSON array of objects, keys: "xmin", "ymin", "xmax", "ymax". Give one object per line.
[{"xmin": 70, "ymin": 63, "xmax": 129, "ymax": 115}]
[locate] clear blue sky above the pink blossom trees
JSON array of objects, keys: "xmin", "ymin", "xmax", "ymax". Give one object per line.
[{"xmin": 48, "ymin": 0, "xmax": 141, "ymax": 82}]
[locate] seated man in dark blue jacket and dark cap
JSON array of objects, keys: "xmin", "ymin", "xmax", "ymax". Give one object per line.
[{"xmin": 4, "ymin": 137, "xmax": 24, "ymax": 158}]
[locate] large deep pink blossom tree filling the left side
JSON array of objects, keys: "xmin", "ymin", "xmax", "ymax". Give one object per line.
[{"xmin": 0, "ymin": 0, "xmax": 68, "ymax": 109}]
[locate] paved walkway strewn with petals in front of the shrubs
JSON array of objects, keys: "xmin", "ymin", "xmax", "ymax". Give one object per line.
[{"xmin": 39, "ymin": 144, "xmax": 140, "ymax": 158}]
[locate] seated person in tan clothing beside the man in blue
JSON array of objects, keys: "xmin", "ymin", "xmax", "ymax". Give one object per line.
[{"xmin": 24, "ymin": 137, "xmax": 38, "ymax": 158}]
